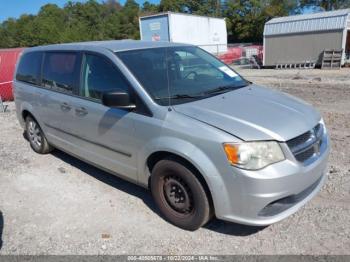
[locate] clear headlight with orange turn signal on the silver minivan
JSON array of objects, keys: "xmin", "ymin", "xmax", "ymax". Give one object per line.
[{"xmin": 224, "ymin": 141, "xmax": 285, "ymax": 170}]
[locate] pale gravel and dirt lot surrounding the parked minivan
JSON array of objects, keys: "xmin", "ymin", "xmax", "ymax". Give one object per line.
[{"xmin": 0, "ymin": 69, "xmax": 350, "ymax": 254}]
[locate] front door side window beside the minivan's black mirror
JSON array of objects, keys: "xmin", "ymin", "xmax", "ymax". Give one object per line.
[{"xmin": 80, "ymin": 54, "xmax": 129, "ymax": 100}]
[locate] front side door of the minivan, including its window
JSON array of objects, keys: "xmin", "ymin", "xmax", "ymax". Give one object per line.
[{"xmin": 67, "ymin": 53, "xmax": 137, "ymax": 181}]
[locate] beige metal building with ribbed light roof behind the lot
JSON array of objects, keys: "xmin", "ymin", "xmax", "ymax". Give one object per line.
[{"xmin": 263, "ymin": 9, "xmax": 350, "ymax": 66}]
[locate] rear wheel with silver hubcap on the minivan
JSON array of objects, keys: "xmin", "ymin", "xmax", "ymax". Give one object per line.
[{"xmin": 26, "ymin": 116, "xmax": 53, "ymax": 154}]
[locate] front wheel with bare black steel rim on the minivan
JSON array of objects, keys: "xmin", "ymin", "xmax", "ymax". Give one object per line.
[{"xmin": 151, "ymin": 158, "xmax": 212, "ymax": 231}]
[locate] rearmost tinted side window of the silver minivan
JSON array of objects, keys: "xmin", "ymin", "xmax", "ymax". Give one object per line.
[{"xmin": 16, "ymin": 52, "xmax": 43, "ymax": 85}]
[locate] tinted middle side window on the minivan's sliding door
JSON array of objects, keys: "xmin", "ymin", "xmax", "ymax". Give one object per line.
[{"xmin": 42, "ymin": 52, "xmax": 80, "ymax": 94}]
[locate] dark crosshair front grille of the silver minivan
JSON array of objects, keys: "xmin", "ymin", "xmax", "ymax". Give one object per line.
[{"xmin": 287, "ymin": 124, "xmax": 323, "ymax": 163}]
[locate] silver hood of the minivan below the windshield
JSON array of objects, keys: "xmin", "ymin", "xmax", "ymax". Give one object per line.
[{"xmin": 173, "ymin": 85, "xmax": 321, "ymax": 142}]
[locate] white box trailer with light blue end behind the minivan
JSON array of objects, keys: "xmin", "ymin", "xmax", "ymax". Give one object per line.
[{"xmin": 139, "ymin": 12, "xmax": 227, "ymax": 54}]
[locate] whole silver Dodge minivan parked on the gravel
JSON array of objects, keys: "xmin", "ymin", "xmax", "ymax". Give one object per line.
[{"xmin": 14, "ymin": 40, "xmax": 329, "ymax": 230}]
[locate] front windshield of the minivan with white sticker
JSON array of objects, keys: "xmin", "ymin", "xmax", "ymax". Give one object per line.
[{"xmin": 116, "ymin": 46, "xmax": 248, "ymax": 105}]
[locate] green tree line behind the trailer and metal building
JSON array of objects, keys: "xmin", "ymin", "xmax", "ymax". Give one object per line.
[{"xmin": 0, "ymin": 0, "xmax": 350, "ymax": 48}]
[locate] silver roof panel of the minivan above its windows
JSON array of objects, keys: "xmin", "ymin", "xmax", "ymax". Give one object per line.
[{"xmin": 28, "ymin": 40, "xmax": 189, "ymax": 52}]
